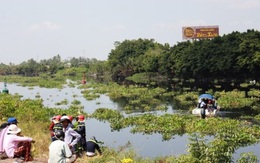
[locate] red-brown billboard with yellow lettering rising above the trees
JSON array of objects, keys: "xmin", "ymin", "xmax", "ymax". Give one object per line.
[{"xmin": 182, "ymin": 26, "xmax": 219, "ymax": 39}]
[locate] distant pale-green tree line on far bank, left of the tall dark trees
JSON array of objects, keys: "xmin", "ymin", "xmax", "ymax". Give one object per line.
[{"xmin": 0, "ymin": 54, "xmax": 107, "ymax": 77}]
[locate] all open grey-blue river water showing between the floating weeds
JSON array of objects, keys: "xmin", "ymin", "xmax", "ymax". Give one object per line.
[{"xmin": 0, "ymin": 82, "xmax": 260, "ymax": 160}]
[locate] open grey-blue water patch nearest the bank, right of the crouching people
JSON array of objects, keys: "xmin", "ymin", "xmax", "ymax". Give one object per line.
[{"xmin": 86, "ymin": 119, "xmax": 188, "ymax": 157}]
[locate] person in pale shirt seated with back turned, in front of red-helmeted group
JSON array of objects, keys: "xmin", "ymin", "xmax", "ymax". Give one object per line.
[{"xmin": 48, "ymin": 130, "xmax": 77, "ymax": 163}]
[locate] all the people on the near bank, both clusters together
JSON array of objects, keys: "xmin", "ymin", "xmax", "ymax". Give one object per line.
[{"xmin": 0, "ymin": 115, "xmax": 102, "ymax": 163}]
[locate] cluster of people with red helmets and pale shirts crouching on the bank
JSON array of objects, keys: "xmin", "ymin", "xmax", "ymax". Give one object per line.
[{"xmin": 49, "ymin": 115, "xmax": 102, "ymax": 163}]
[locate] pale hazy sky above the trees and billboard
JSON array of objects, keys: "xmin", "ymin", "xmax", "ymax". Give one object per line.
[{"xmin": 0, "ymin": 0, "xmax": 260, "ymax": 64}]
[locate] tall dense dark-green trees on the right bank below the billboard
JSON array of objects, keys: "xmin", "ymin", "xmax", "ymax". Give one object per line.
[{"xmin": 108, "ymin": 30, "xmax": 260, "ymax": 81}]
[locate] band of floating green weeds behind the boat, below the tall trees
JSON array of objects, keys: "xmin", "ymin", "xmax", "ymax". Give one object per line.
[{"xmin": 79, "ymin": 83, "xmax": 260, "ymax": 114}]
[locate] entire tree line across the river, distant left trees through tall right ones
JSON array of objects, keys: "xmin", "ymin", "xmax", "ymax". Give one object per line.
[{"xmin": 0, "ymin": 30, "xmax": 260, "ymax": 85}]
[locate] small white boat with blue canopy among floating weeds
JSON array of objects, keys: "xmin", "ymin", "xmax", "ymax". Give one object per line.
[{"xmin": 192, "ymin": 94, "xmax": 219, "ymax": 117}]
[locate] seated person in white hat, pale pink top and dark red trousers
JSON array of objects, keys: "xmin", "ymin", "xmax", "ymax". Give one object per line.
[{"xmin": 4, "ymin": 124, "xmax": 33, "ymax": 161}]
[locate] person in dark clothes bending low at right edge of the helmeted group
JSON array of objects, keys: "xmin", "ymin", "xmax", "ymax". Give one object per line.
[{"xmin": 86, "ymin": 136, "xmax": 102, "ymax": 157}]
